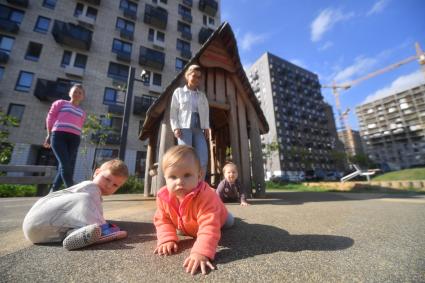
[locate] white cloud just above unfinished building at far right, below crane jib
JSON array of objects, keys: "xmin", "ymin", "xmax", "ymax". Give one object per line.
[{"xmin": 362, "ymin": 70, "xmax": 425, "ymax": 104}]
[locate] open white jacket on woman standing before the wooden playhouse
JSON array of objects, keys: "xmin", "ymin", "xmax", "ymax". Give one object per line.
[{"xmin": 170, "ymin": 85, "xmax": 210, "ymax": 131}]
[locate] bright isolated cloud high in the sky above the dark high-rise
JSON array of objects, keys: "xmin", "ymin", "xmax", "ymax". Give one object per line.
[{"xmin": 310, "ymin": 8, "xmax": 354, "ymax": 42}]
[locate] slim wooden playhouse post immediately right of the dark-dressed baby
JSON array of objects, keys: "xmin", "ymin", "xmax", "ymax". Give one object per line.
[{"xmin": 236, "ymin": 93, "xmax": 252, "ymax": 199}]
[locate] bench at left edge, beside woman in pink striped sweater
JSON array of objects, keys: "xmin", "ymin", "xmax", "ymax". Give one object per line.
[{"xmin": 0, "ymin": 164, "xmax": 57, "ymax": 196}]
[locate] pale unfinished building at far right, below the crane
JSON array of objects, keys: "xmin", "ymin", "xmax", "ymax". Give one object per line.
[{"xmin": 356, "ymin": 85, "xmax": 425, "ymax": 170}]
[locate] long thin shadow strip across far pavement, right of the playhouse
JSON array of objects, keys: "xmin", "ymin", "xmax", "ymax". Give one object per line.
[{"xmin": 249, "ymin": 192, "xmax": 421, "ymax": 205}]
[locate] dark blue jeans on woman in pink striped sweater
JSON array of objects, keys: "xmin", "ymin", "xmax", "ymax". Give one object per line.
[{"xmin": 50, "ymin": 131, "xmax": 80, "ymax": 191}]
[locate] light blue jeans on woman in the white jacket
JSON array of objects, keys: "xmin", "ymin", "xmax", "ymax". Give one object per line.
[{"xmin": 177, "ymin": 113, "xmax": 208, "ymax": 172}]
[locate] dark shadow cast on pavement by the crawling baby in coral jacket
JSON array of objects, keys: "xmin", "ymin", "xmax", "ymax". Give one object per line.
[{"xmin": 215, "ymin": 218, "xmax": 354, "ymax": 264}]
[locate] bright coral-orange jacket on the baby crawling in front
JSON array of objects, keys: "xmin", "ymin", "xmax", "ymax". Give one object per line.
[{"xmin": 154, "ymin": 182, "xmax": 228, "ymax": 259}]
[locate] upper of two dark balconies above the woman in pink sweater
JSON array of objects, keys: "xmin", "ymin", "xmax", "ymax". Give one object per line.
[{"xmin": 52, "ymin": 20, "xmax": 93, "ymax": 50}]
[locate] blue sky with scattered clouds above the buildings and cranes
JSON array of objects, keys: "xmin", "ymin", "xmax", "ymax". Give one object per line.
[{"xmin": 221, "ymin": 0, "xmax": 425, "ymax": 129}]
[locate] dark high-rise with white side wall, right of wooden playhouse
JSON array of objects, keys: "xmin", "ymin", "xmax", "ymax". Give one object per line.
[{"xmin": 247, "ymin": 52, "xmax": 337, "ymax": 179}]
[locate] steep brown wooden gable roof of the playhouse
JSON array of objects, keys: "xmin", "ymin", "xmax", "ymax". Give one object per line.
[{"xmin": 139, "ymin": 22, "xmax": 269, "ymax": 140}]
